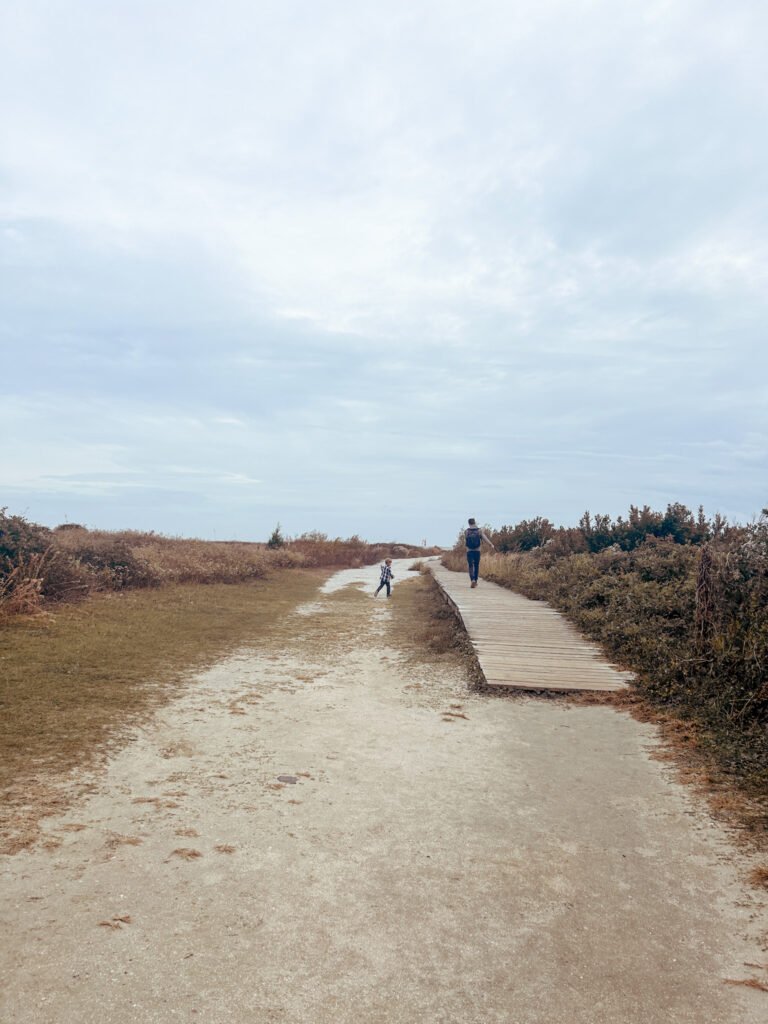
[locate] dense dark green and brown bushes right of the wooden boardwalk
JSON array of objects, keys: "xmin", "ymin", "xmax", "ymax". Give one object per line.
[{"xmin": 443, "ymin": 505, "xmax": 768, "ymax": 791}]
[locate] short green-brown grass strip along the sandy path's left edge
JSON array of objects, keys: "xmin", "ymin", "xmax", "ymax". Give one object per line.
[{"xmin": 0, "ymin": 569, "xmax": 328, "ymax": 852}]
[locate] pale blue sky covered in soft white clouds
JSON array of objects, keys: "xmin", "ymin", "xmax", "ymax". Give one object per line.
[{"xmin": 0, "ymin": 0, "xmax": 768, "ymax": 544}]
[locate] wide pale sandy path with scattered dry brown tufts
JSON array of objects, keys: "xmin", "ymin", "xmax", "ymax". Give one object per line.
[{"xmin": 0, "ymin": 563, "xmax": 768, "ymax": 1024}]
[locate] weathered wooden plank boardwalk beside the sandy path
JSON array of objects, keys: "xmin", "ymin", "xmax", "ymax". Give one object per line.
[{"xmin": 429, "ymin": 560, "xmax": 632, "ymax": 691}]
